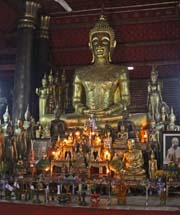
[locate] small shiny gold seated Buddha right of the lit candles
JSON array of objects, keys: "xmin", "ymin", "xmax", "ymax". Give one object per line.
[{"xmin": 122, "ymin": 139, "xmax": 145, "ymax": 180}]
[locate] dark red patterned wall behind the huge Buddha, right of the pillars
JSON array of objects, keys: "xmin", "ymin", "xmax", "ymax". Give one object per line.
[{"xmin": 50, "ymin": 4, "xmax": 180, "ymax": 116}]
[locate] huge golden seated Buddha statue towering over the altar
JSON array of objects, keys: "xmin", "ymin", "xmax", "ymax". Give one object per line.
[{"xmin": 38, "ymin": 15, "xmax": 147, "ymax": 127}]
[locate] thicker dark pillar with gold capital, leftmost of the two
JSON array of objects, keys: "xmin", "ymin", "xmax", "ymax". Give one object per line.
[{"xmin": 12, "ymin": 1, "xmax": 40, "ymax": 121}]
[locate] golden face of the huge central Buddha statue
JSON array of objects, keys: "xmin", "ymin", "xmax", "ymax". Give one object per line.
[{"xmin": 90, "ymin": 32, "xmax": 110, "ymax": 61}]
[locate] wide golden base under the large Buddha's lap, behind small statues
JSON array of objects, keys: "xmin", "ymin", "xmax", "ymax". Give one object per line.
[{"xmin": 40, "ymin": 113, "xmax": 147, "ymax": 128}]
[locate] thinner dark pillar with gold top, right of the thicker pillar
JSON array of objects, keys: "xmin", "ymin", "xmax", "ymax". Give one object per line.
[{"xmin": 31, "ymin": 16, "xmax": 50, "ymax": 120}]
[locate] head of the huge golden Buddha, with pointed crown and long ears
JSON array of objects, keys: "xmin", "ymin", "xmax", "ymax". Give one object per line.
[{"xmin": 89, "ymin": 15, "xmax": 116, "ymax": 63}]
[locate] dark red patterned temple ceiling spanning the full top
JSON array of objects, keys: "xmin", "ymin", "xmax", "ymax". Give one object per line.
[{"xmin": 0, "ymin": 0, "xmax": 180, "ymax": 78}]
